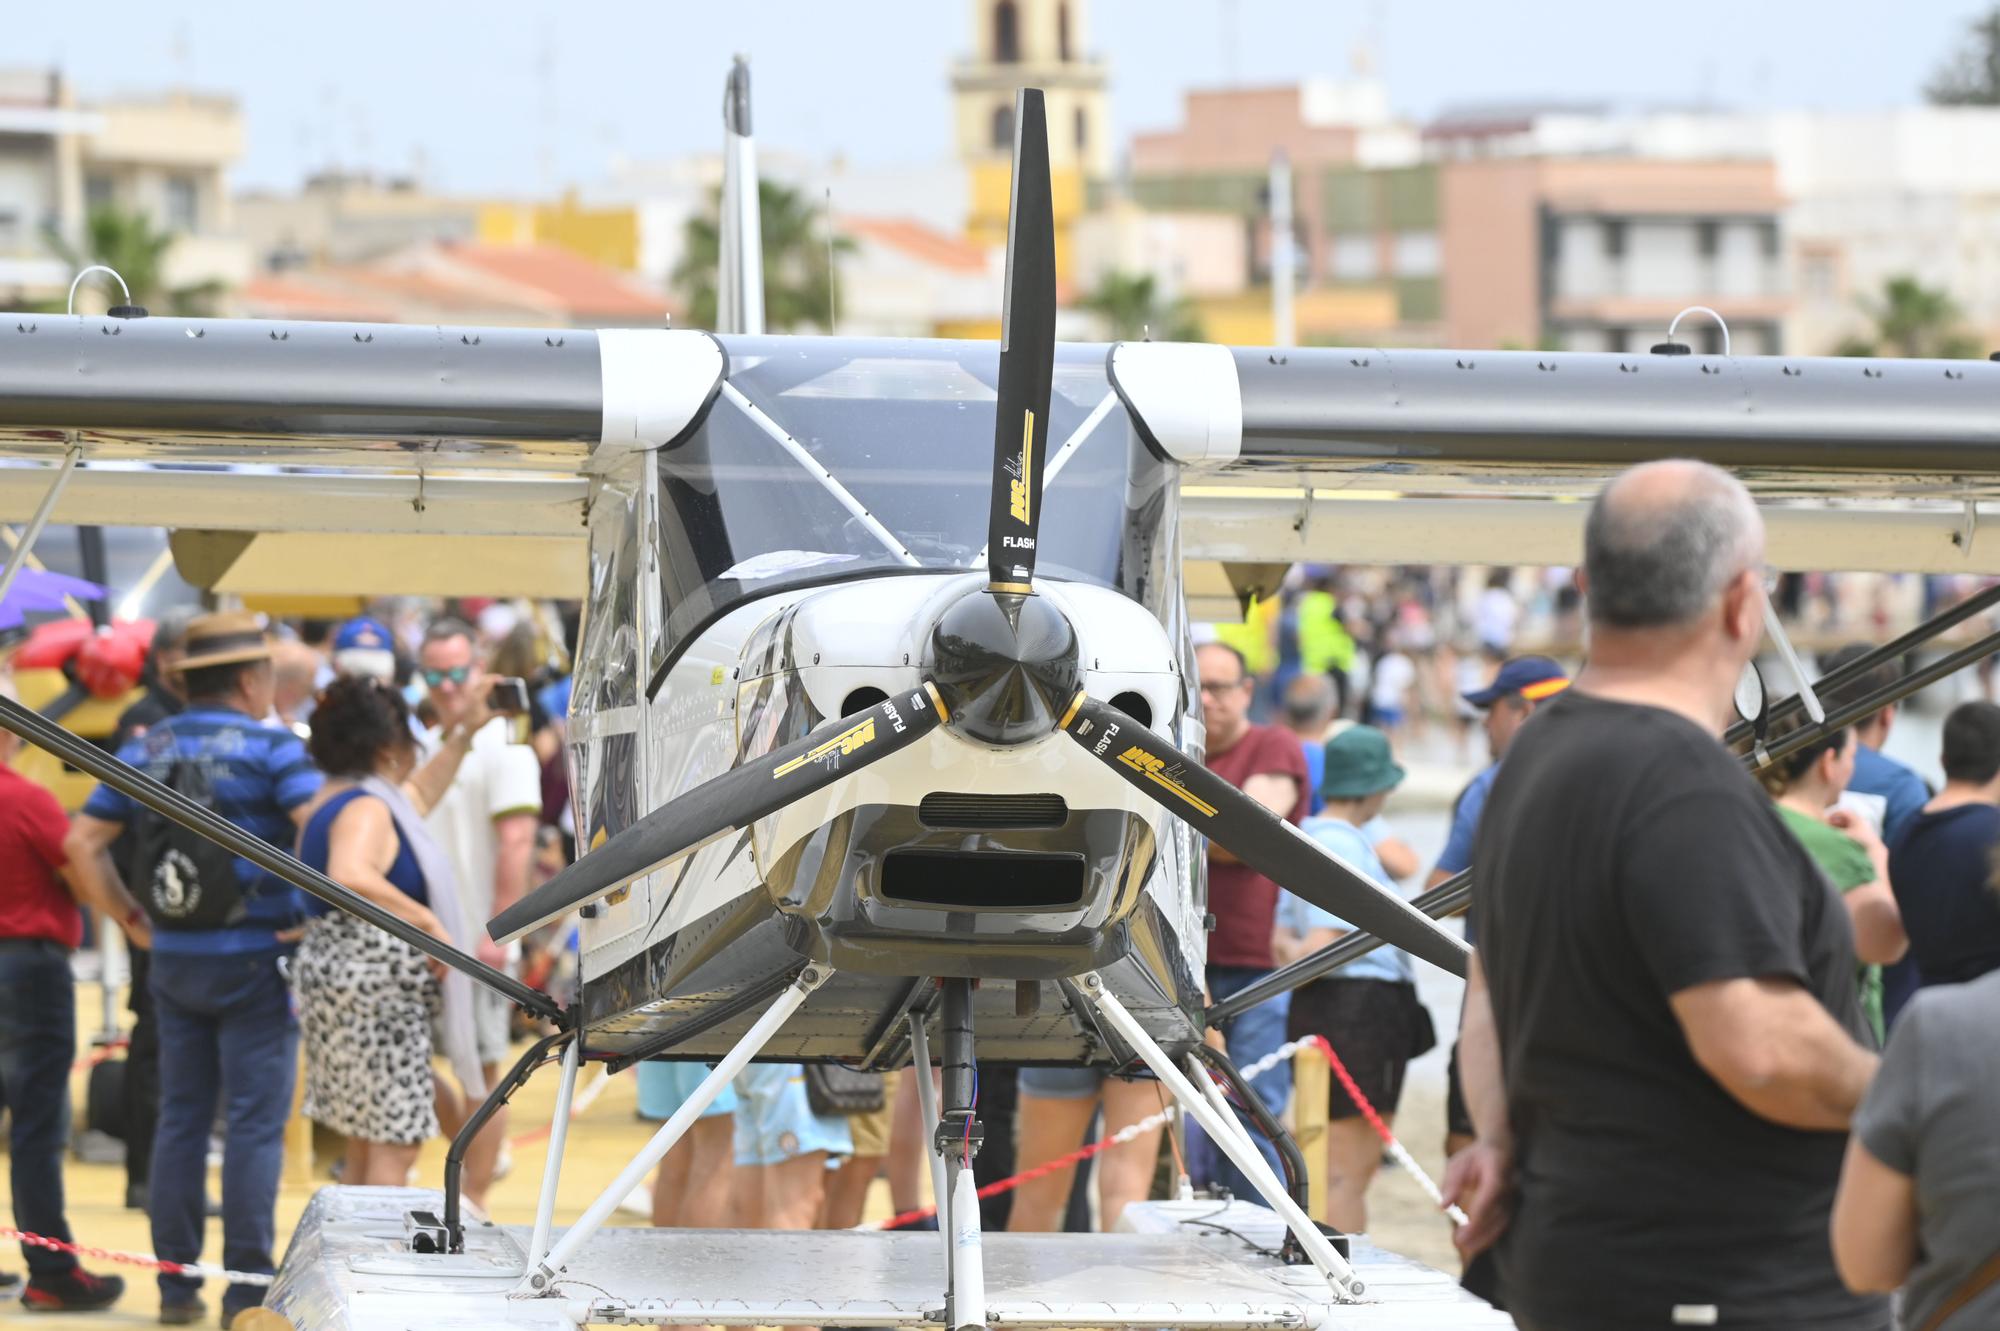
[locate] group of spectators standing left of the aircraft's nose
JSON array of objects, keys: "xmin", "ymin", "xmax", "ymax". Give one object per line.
[{"xmin": 0, "ymin": 606, "xmax": 574, "ymax": 1325}]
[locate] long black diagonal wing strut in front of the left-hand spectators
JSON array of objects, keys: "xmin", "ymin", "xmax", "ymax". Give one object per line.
[{"xmin": 0, "ymin": 695, "xmax": 568, "ymax": 1025}]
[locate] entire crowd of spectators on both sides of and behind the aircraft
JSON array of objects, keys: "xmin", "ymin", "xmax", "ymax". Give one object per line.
[{"xmin": 0, "ymin": 464, "xmax": 2000, "ymax": 1331}]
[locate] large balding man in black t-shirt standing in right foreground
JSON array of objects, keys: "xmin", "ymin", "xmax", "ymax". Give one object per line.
[{"xmin": 1446, "ymin": 462, "xmax": 1890, "ymax": 1331}]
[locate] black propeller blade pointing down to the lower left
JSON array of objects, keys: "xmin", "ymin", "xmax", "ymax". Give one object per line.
[{"xmin": 486, "ymin": 683, "xmax": 946, "ymax": 943}]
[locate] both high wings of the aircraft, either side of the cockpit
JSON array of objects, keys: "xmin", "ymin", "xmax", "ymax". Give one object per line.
[{"xmin": 0, "ymin": 316, "xmax": 2000, "ymax": 596}]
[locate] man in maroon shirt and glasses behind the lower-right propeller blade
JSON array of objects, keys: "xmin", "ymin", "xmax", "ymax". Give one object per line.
[{"xmin": 1188, "ymin": 642, "xmax": 1310, "ymax": 1197}]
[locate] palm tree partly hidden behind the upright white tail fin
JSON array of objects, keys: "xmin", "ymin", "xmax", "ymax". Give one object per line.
[{"xmin": 672, "ymin": 180, "xmax": 854, "ymax": 332}]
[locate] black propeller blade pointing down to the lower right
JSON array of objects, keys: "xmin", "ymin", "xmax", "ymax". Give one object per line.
[{"xmin": 1062, "ymin": 693, "xmax": 1470, "ymax": 975}]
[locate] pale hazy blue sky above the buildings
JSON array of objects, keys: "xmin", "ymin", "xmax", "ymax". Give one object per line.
[{"xmin": 19, "ymin": 0, "xmax": 1986, "ymax": 194}]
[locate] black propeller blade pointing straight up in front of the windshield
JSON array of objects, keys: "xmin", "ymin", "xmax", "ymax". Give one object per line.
[{"xmin": 986, "ymin": 88, "xmax": 1056, "ymax": 596}]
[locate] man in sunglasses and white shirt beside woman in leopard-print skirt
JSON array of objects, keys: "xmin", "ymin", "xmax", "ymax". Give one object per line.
[{"xmin": 416, "ymin": 618, "xmax": 542, "ymax": 1207}]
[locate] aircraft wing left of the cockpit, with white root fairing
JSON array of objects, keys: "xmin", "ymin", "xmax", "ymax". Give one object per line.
[{"xmin": 0, "ymin": 316, "xmax": 724, "ymax": 596}]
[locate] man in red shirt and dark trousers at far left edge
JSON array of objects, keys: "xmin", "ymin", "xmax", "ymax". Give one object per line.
[{"xmin": 0, "ymin": 683, "xmax": 146, "ymax": 1313}]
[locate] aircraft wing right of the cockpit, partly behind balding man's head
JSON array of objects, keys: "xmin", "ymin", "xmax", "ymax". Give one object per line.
[{"xmin": 1112, "ymin": 344, "xmax": 2000, "ymax": 574}]
